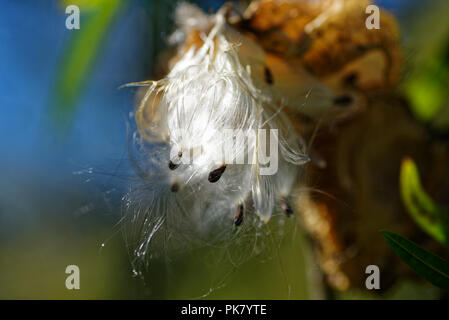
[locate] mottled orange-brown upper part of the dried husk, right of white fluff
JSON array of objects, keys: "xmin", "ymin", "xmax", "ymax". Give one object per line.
[{"xmin": 244, "ymin": 0, "xmax": 402, "ymax": 90}]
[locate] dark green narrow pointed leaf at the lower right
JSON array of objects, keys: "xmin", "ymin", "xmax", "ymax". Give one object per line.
[{"xmin": 381, "ymin": 231, "xmax": 449, "ymax": 290}]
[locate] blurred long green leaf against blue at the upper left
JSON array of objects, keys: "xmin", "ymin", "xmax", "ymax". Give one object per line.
[{"xmin": 52, "ymin": 0, "xmax": 123, "ymax": 126}]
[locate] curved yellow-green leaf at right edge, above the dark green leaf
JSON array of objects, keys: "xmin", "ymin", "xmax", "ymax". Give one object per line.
[{"xmin": 400, "ymin": 158, "xmax": 449, "ymax": 245}]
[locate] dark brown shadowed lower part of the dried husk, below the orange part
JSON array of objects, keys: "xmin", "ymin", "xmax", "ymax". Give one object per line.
[{"xmin": 296, "ymin": 95, "xmax": 449, "ymax": 290}]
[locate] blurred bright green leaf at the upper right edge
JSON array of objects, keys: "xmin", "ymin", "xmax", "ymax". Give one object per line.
[{"xmin": 402, "ymin": 0, "xmax": 449, "ymax": 132}]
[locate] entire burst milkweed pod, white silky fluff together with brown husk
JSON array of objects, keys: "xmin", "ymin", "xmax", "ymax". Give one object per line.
[{"xmin": 121, "ymin": 0, "xmax": 449, "ymax": 290}]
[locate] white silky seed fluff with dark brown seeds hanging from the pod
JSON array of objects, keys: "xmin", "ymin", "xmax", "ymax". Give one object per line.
[{"xmin": 126, "ymin": 4, "xmax": 308, "ymax": 278}]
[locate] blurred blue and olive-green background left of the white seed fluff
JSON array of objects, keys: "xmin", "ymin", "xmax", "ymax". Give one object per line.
[{"xmin": 0, "ymin": 0, "xmax": 440, "ymax": 298}]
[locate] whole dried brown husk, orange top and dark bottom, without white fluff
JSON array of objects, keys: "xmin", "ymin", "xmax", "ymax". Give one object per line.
[{"xmin": 240, "ymin": 0, "xmax": 449, "ymax": 290}]
